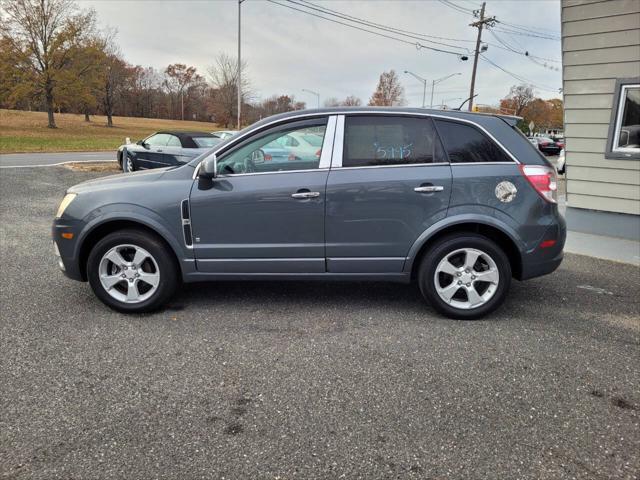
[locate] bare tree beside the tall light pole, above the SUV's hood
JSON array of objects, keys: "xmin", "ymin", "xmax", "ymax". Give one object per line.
[{"xmin": 208, "ymin": 53, "xmax": 251, "ymax": 127}]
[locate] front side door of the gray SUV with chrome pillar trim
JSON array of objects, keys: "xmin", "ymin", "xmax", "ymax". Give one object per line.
[{"xmin": 190, "ymin": 116, "xmax": 335, "ymax": 274}]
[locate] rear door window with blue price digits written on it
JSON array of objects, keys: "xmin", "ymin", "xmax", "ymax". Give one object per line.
[{"xmin": 342, "ymin": 115, "xmax": 446, "ymax": 167}]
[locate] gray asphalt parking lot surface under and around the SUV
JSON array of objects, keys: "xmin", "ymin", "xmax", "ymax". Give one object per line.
[{"xmin": 0, "ymin": 167, "xmax": 640, "ymax": 479}]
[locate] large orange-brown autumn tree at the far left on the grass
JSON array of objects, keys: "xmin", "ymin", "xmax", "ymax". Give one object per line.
[{"xmin": 0, "ymin": 0, "xmax": 95, "ymax": 128}]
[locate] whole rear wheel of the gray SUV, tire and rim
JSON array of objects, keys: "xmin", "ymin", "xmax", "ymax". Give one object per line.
[{"xmin": 418, "ymin": 233, "xmax": 511, "ymax": 320}]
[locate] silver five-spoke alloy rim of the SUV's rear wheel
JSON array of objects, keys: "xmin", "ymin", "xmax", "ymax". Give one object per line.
[{"xmin": 434, "ymin": 248, "xmax": 500, "ymax": 310}]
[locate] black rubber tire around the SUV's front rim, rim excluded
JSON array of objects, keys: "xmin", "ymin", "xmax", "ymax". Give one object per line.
[{"xmin": 87, "ymin": 229, "xmax": 180, "ymax": 313}]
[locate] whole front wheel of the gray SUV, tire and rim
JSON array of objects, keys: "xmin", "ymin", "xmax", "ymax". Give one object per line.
[{"xmin": 87, "ymin": 230, "xmax": 178, "ymax": 313}]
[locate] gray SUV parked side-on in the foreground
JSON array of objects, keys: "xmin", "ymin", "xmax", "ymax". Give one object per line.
[{"xmin": 53, "ymin": 108, "xmax": 566, "ymax": 319}]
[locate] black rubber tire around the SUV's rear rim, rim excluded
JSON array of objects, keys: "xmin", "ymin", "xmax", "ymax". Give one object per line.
[{"xmin": 418, "ymin": 233, "xmax": 511, "ymax": 320}]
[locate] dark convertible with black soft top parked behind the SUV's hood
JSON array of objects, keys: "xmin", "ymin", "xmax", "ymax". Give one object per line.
[{"xmin": 117, "ymin": 131, "xmax": 221, "ymax": 172}]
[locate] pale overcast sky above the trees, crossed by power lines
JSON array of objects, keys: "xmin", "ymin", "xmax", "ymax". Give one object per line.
[{"xmin": 84, "ymin": 0, "xmax": 561, "ymax": 107}]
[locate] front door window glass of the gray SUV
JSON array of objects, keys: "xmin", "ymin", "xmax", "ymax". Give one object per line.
[{"xmin": 218, "ymin": 119, "xmax": 326, "ymax": 175}]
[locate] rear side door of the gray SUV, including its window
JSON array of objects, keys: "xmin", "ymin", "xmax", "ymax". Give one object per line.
[{"xmin": 325, "ymin": 114, "xmax": 451, "ymax": 273}]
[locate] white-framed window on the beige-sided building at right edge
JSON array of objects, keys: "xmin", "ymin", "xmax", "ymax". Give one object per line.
[{"xmin": 607, "ymin": 80, "xmax": 640, "ymax": 159}]
